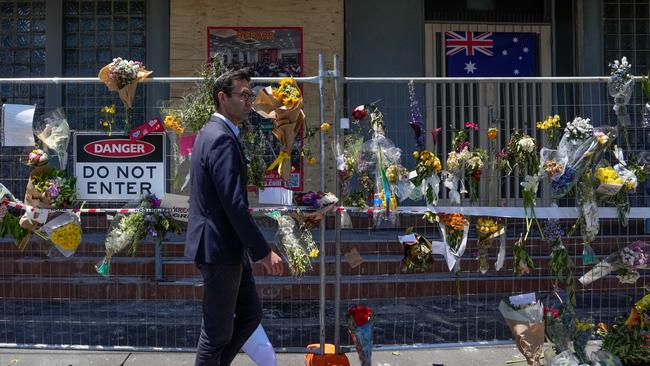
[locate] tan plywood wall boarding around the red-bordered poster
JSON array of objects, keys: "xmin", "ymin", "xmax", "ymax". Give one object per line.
[{"xmin": 169, "ymin": 0, "xmax": 344, "ymax": 194}]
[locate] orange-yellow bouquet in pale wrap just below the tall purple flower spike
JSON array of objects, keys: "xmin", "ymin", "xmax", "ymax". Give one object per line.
[{"xmin": 411, "ymin": 150, "xmax": 442, "ymax": 206}]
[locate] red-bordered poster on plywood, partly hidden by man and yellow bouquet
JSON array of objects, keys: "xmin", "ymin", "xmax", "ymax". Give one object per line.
[{"xmin": 208, "ymin": 27, "xmax": 304, "ymax": 190}]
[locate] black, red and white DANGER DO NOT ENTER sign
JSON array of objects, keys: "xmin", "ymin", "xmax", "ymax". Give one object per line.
[{"xmin": 74, "ymin": 132, "xmax": 166, "ymax": 201}]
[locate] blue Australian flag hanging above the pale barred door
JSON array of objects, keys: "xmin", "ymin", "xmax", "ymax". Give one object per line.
[{"xmin": 445, "ymin": 32, "xmax": 539, "ymax": 77}]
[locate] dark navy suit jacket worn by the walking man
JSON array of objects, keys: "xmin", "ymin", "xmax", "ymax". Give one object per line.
[{"xmin": 185, "ymin": 115, "xmax": 271, "ymax": 264}]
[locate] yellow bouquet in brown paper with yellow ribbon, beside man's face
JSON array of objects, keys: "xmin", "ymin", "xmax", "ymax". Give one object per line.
[{"xmin": 253, "ymin": 78, "xmax": 305, "ymax": 181}]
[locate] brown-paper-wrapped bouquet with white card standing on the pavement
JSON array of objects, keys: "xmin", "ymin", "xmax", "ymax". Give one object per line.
[{"xmin": 499, "ymin": 300, "xmax": 544, "ymax": 366}]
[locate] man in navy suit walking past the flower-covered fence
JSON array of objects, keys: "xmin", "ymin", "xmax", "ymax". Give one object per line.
[{"xmin": 185, "ymin": 70, "xmax": 284, "ymax": 366}]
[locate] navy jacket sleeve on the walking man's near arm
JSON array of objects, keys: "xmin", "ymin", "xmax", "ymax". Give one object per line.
[{"xmin": 206, "ymin": 135, "xmax": 271, "ymax": 262}]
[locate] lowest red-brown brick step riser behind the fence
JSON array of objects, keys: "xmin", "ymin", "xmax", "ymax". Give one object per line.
[{"xmin": 0, "ymin": 273, "xmax": 636, "ymax": 301}]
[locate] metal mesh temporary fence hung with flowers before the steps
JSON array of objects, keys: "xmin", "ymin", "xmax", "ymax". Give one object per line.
[{"xmin": 0, "ymin": 56, "xmax": 650, "ymax": 352}]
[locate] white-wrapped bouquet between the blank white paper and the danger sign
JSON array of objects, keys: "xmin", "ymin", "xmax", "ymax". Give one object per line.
[{"xmin": 35, "ymin": 108, "xmax": 70, "ymax": 170}]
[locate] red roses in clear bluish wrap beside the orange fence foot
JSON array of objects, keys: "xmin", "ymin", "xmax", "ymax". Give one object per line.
[{"xmin": 346, "ymin": 306, "xmax": 374, "ymax": 366}]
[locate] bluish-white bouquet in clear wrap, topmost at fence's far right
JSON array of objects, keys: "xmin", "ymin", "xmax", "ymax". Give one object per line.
[{"xmin": 607, "ymin": 56, "xmax": 634, "ymax": 126}]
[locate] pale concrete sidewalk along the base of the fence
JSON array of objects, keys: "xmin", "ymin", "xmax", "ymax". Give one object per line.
[{"xmin": 0, "ymin": 344, "xmax": 526, "ymax": 366}]
